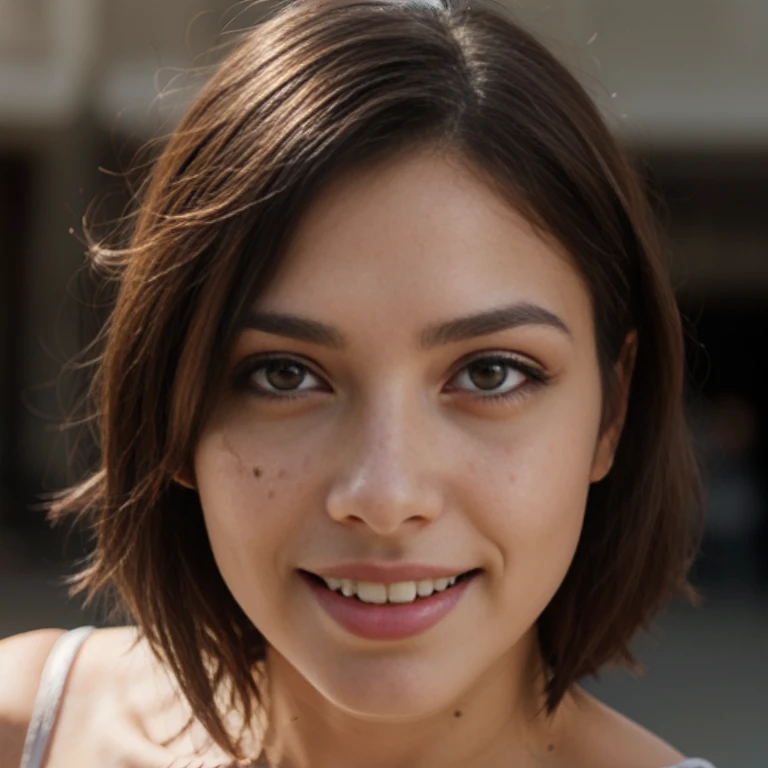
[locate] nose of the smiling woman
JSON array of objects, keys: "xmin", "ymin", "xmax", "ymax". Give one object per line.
[{"xmin": 326, "ymin": 390, "xmax": 444, "ymax": 537}]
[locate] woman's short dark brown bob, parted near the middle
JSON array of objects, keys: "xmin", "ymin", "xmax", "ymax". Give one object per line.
[{"xmin": 49, "ymin": 0, "xmax": 700, "ymax": 759}]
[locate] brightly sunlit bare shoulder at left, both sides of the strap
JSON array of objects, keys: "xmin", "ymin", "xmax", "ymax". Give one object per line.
[{"xmin": 0, "ymin": 626, "xmax": 236, "ymax": 768}]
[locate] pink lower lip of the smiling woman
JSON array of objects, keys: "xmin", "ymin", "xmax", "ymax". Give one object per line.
[{"xmin": 303, "ymin": 574, "xmax": 478, "ymax": 640}]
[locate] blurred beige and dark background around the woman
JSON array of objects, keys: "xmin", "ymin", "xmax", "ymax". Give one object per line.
[{"xmin": 0, "ymin": 0, "xmax": 768, "ymax": 768}]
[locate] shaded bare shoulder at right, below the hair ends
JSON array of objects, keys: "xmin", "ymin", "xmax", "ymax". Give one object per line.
[{"xmin": 569, "ymin": 691, "xmax": 685, "ymax": 768}]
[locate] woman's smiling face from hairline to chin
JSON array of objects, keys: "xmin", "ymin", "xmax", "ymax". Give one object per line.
[{"xmin": 195, "ymin": 152, "xmax": 611, "ymax": 718}]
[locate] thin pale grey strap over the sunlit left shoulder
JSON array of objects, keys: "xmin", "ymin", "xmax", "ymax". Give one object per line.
[{"xmin": 19, "ymin": 626, "xmax": 95, "ymax": 768}]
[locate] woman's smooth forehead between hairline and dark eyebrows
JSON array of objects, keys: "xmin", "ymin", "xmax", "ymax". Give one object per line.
[{"xmin": 255, "ymin": 146, "xmax": 591, "ymax": 342}]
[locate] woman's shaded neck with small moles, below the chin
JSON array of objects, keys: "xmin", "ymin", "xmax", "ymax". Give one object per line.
[{"xmin": 264, "ymin": 632, "xmax": 568, "ymax": 768}]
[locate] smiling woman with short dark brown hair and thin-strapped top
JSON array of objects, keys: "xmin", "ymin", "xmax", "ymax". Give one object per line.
[{"xmin": 0, "ymin": 0, "xmax": 720, "ymax": 768}]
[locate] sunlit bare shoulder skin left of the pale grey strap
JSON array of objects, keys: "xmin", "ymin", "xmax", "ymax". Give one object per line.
[{"xmin": 0, "ymin": 629, "xmax": 66, "ymax": 768}]
